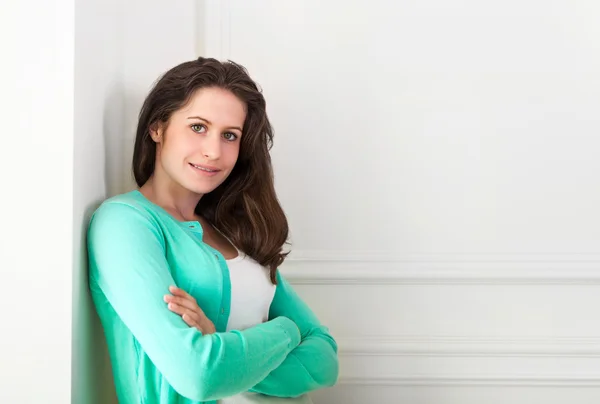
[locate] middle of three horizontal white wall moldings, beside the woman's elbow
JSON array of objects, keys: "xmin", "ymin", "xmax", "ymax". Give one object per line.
[{"xmin": 337, "ymin": 336, "xmax": 600, "ymax": 358}]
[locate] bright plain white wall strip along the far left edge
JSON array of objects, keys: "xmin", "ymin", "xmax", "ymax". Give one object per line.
[{"xmin": 0, "ymin": 0, "xmax": 74, "ymax": 404}]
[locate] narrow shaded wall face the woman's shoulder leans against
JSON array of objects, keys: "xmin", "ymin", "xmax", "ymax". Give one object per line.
[{"xmin": 72, "ymin": 0, "xmax": 125, "ymax": 404}]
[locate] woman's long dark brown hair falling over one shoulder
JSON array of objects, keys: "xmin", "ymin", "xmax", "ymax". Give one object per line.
[{"xmin": 133, "ymin": 57, "xmax": 289, "ymax": 284}]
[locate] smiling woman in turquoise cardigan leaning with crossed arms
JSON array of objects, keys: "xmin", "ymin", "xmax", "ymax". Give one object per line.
[{"xmin": 88, "ymin": 58, "xmax": 338, "ymax": 404}]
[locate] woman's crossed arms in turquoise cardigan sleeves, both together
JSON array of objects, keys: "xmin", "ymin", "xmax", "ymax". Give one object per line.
[{"xmin": 88, "ymin": 204, "xmax": 338, "ymax": 401}]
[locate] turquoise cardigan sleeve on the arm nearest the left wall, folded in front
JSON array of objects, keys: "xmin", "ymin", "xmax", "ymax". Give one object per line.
[{"xmin": 88, "ymin": 202, "xmax": 300, "ymax": 401}]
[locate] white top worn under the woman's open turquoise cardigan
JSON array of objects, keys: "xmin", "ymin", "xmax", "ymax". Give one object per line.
[{"xmin": 217, "ymin": 251, "xmax": 312, "ymax": 404}]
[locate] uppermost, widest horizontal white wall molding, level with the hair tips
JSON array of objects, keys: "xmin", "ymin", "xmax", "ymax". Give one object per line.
[{"xmin": 282, "ymin": 251, "xmax": 600, "ymax": 285}]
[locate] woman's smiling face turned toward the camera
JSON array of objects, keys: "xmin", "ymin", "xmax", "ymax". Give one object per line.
[{"xmin": 151, "ymin": 88, "xmax": 246, "ymax": 195}]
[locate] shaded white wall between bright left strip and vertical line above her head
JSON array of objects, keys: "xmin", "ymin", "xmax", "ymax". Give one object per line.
[{"xmin": 71, "ymin": 0, "xmax": 196, "ymax": 404}]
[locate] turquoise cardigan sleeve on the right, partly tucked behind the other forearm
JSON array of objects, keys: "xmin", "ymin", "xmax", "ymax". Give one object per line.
[{"xmin": 250, "ymin": 271, "xmax": 339, "ymax": 397}]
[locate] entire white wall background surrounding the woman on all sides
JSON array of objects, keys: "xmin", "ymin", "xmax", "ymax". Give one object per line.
[{"xmin": 0, "ymin": 0, "xmax": 600, "ymax": 404}]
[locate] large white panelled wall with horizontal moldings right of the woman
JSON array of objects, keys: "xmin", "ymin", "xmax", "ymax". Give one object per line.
[{"xmin": 199, "ymin": 0, "xmax": 600, "ymax": 404}]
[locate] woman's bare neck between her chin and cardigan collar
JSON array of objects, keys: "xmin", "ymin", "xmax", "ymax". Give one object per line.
[{"xmin": 140, "ymin": 170, "xmax": 202, "ymax": 221}]
